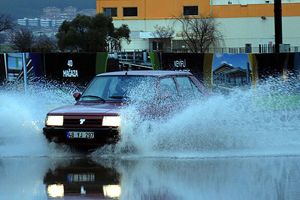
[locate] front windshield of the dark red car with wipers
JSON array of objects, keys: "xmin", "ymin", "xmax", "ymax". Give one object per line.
[{"xmin": 80, "ymin": 75, "xmax": 158, "ymax": 101}]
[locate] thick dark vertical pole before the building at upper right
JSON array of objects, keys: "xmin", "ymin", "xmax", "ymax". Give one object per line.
[{"xmin": 274, "ymin": 0, "xmax": 282, "ymax": 53}]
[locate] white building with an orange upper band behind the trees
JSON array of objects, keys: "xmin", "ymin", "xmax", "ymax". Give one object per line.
[{"xmin": 97, "ymin": 0, "xmax": 300, "ymax": 53}]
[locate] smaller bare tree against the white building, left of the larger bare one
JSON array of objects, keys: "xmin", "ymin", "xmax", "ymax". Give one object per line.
[{"xmin": 151, "ymin": 25, "xmax": 175, "ymax": 51}]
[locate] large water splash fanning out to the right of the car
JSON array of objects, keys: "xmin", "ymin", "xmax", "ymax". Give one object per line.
[{"xmin": 95, "ymin": 78, "xmax": 300, "ymax": 157}]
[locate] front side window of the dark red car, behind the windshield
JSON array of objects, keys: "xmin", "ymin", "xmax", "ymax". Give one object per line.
[{"xmin": 159, "ymin": 78, "xmax": 179, "ymax": 101}]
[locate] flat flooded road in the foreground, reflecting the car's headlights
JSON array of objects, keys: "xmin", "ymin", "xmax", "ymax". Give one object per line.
[{"xmin": 0, "ymin": 156, "xmax": 300, "ymax": 200}]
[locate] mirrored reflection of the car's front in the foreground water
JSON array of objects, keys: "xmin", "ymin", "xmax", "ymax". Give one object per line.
[{"xmin": 44, "ymin": 157, "xmax": 122, "ymax": 199}]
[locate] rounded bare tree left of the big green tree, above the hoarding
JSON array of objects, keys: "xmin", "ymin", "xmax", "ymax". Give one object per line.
[{"xmin": 11, "ymin": 29, "xmax": 34, "ymax": 52}]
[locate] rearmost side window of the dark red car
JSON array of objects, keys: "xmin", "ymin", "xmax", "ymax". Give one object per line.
[{"xmin": 176, "ymin": 77, "xmax": 203, "ymax": 100}]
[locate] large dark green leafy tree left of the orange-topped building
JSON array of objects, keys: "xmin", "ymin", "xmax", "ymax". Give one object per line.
[{"xmin": 56, "ymin": 13, "xmax": 130, "ymax": 52}]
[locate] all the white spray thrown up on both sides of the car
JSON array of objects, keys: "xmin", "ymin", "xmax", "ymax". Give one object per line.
[{"xmin": 0, "ymin": 78, "xmax": 300, "ymax": 157}]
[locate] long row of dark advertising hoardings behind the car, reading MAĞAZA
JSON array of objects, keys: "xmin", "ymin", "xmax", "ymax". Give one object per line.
[{"xmin": 0, "ymin": 52, "xmax": 300, "ymax": 92}]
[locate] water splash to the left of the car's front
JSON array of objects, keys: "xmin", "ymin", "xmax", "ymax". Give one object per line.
[{"xmin": 0, "ymin": 84, "xmax": 78, "ymax": 157}]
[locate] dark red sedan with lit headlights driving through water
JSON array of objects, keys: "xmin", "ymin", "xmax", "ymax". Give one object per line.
[{"xmin": 43, "ymin": 70, "xmax": 208, "ymax": 148}]
